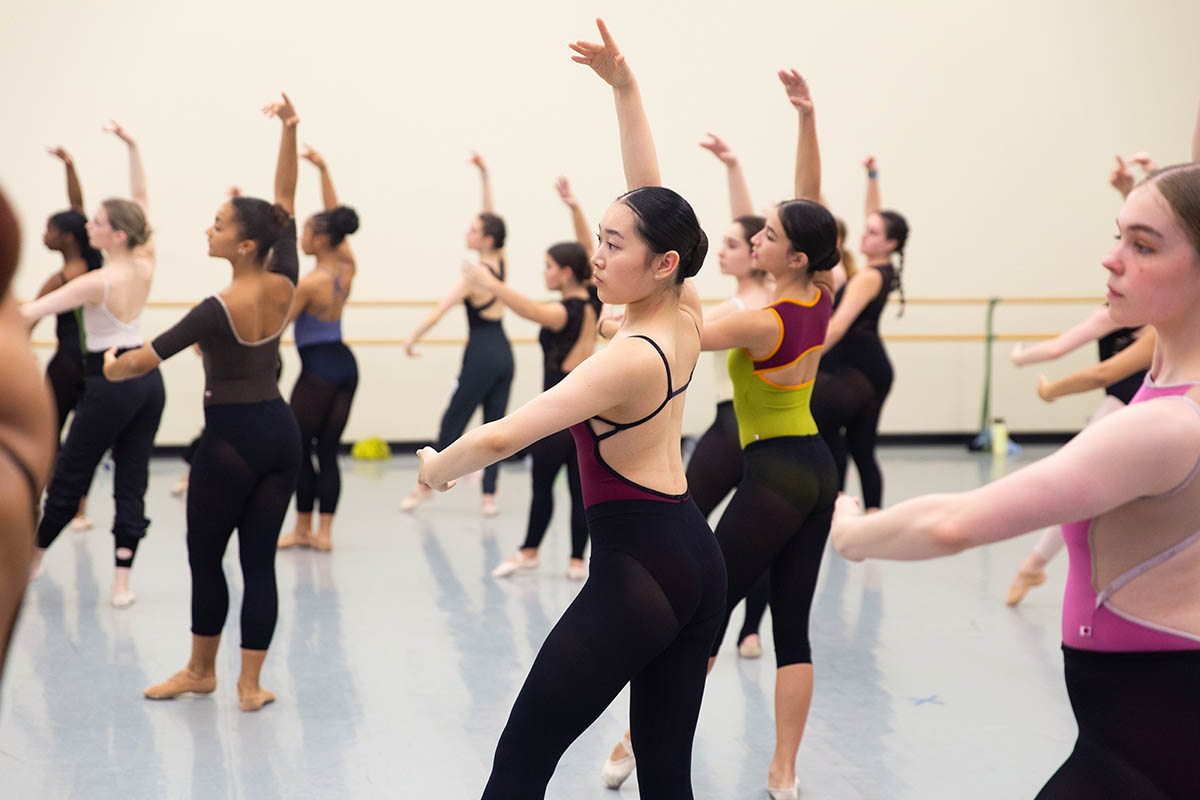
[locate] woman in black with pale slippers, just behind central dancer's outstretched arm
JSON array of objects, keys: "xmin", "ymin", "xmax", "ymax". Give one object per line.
[{"xmin": 477, "ymin": 178, "xmax": 601, "ymax": 581}]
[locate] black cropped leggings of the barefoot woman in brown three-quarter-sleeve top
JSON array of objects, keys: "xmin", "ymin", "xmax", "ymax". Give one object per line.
[{"xmin": 187, "ymin": 399, "xmax": 300, "ymax": 650}]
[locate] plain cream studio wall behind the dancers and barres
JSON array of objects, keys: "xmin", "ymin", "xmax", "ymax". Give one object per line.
[{"xmin": 0, "ymin": 0, "xmax": 1200, "ymax": 444}]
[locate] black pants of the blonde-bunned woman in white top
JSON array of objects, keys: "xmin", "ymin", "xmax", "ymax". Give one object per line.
[{"xmin": 37, "ymin": 353, "xmax": 167, "ymax": 566}]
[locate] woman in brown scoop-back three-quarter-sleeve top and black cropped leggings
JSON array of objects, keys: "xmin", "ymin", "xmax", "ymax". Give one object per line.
[{"xmin": 104, "ymin": 95, "xmax": 300, "ymax": 711}]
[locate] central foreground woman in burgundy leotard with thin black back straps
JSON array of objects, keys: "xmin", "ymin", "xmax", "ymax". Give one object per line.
[{"xmin": 419, "ymin": 20, "xmax": 725, "ymax": 800}]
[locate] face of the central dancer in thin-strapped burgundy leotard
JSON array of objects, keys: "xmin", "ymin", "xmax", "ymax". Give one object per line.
[{"xmin": 592, "ymin": 203, "xmax": 679, "ymax": 306}]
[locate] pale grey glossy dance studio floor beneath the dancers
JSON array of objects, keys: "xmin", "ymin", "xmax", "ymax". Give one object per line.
[{"xmin": 0, "ymin": 447, "xmax": 1074, "ymax": 800}]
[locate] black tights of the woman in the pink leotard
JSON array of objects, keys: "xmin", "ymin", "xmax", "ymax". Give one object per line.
[{"xmin": 1038, "ymin": 645, "xmax": 1200, "ymax": 800}]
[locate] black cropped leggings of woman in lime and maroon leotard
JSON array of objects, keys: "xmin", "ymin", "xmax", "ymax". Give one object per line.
[{"xmin": 712, "ymin": 435, "xmax": 838, "ymax": 667}]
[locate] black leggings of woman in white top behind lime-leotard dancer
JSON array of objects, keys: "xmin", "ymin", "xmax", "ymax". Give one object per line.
[{"xmin": 688, "ymin": 401, "xmax": 770, "ymax": 643}]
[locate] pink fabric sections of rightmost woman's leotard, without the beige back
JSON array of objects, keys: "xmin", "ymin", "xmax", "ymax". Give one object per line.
[{"xmin": 1062, "ymin": 378, "xmax": 1200, "ymax": 652}]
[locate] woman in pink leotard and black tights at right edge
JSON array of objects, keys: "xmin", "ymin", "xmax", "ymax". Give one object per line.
[{"xmin": 833, "ymin": 163, "xmax": 1200, "ymax": 800}]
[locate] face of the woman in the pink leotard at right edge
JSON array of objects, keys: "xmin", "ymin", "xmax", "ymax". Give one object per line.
[{"xmin": 1100, "ymin": 182, "xmax": 1200, "ymax": 327}]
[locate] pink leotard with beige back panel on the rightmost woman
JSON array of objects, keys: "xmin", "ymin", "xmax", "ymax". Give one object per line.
[{"xmin": 1062, "ymin": 377, "xmax": 1200, "ymax": 652}]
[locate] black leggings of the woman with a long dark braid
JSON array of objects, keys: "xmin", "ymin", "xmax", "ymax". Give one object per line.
[{"xmin": 812, "ymin": 367, "xmax": 887, "ymax": 509}]
